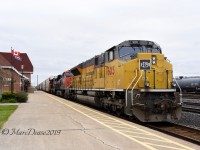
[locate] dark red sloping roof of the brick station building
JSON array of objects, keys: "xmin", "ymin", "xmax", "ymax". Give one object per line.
[{"xmin": 0, "ymin": 52, "xmax": 33, "ymax": 73}]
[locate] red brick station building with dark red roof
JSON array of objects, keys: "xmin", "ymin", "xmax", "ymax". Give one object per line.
[{"xmin": 0, "ymin": 52, "xmax": 33, "ymax": 92}]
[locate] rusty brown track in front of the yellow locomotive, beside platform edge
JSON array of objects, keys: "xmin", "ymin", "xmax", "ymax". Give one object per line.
[{"xmin": 145, "ymin": 122, "xmax": 200, "ymax": 145}]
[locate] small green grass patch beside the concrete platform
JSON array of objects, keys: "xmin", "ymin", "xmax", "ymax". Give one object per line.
[{"xmin": 0, "ymin": 105, "xmax": 18, "ymax": 128}]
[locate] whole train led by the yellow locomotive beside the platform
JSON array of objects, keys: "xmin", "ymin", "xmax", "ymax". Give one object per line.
[{"xmin": 38, "ymin": 40, "xmax": 181, "ymax": 122}]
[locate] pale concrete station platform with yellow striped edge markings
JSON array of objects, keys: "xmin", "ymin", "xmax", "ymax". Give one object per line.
[{"xmin": 0, "ymin": 92, "xmax": 199, "ymax": 150}]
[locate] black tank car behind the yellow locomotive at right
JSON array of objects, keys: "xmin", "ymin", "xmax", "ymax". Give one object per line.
[{"xmin": 176, "ymin": 76, "xmax": 200, "ymax": 92}]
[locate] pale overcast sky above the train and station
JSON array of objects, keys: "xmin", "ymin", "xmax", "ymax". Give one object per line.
[{"xmin": 0, "ymin": 0, "xmax": 200, "ymax": 85}]
